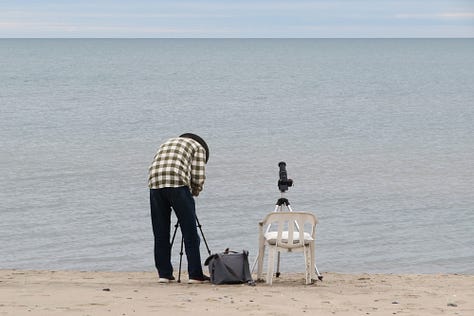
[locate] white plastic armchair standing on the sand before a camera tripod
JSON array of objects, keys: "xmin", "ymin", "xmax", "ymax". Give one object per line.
[{"xmin": 257, "ymin": 212, "xmax": 318, "ymax": 285}]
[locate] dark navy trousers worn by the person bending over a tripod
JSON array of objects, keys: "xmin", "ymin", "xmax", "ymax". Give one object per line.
[{"xmin": 150, "ymin": 186, "xmax": 203, "ymax": 279}]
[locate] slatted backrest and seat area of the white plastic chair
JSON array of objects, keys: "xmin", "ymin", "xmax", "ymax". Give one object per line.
[{"xmin": 260, "ymin": 212, "xmax": 318, "ymax": 249}]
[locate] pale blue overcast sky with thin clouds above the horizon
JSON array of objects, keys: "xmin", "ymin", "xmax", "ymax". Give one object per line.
[{"xmin": 0, "ymin": 0, "xmax": 474, "ymax": 38}]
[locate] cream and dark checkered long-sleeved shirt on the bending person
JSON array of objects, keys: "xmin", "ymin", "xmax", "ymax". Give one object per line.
[{"xmin": 148, "ymin": 137, "xmax": 206, "ymax": 196}]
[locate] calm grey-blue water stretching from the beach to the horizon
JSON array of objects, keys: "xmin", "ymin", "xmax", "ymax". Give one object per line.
[{"xmin": 0, "ymin": 39, "xmax": 474, "ymax": 274}]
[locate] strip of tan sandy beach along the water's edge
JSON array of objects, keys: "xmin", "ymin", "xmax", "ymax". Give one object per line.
[{"xmin": 0, "ymin": 270, "xmax": 474, "ymax": 316}]
